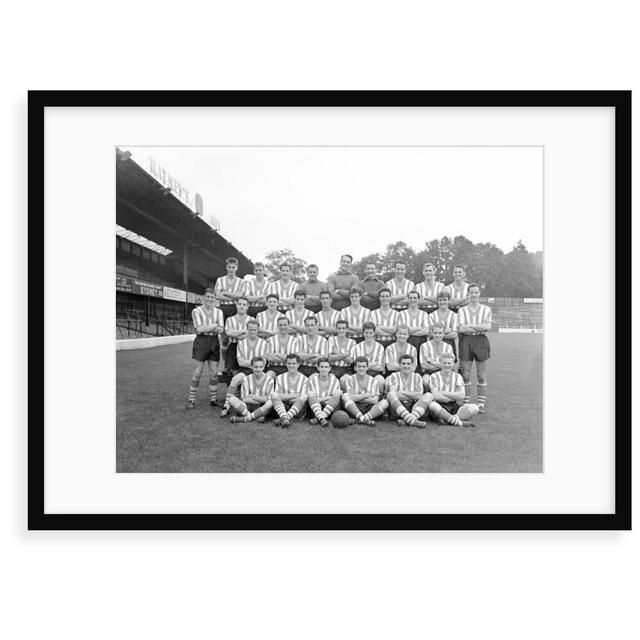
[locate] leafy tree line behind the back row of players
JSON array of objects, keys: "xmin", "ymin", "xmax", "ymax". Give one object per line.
[{"xmin": 265, "ymin": 236, "xmax": 543, "ymax": 298}]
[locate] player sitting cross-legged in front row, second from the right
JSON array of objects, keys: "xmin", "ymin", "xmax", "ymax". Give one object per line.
[{"xmin": 387, "ymin": 353, "xmax": 433, "ymax": 429}]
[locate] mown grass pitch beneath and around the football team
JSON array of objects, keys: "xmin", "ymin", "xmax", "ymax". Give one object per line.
[{"xmin": 116, "ymin": 333, "xmax": 543, "ymax": 473}]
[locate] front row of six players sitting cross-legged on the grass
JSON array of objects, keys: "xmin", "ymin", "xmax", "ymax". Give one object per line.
[{"xmin": 221, "ymin": 352, "xmax": 479, "ymax": 428}]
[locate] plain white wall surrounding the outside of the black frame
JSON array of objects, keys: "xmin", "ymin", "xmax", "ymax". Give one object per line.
[{"xmin": 0, "ymin": 0, "xmax": 640, "ymax": 640}]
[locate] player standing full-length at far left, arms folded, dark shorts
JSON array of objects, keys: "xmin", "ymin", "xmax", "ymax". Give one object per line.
[{"xmin": 185, "ymin": 289, "xmax": 224, "ymax": 409}]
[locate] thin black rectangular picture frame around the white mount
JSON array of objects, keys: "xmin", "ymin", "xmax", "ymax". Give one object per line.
[{"xmin": 28, "ymin": 91, "xmax": 632, "ymax": 530}]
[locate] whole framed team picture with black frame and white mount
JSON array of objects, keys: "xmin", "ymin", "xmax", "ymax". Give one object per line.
[{"xmin": 28, "ymin": 91, "xmax": 632, "ymax": 530}]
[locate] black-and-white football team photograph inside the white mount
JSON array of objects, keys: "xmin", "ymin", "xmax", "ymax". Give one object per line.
[{"xmin": 113, "ymin": 145, "xmax": 544, "ymax": 473}]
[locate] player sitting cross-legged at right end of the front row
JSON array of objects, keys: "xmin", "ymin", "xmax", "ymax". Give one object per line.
[{"xmin": 429, "ymin": 353, "xmax": 478, "ymax": 427}]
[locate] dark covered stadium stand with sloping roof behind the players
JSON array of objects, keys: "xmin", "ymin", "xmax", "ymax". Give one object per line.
[{"xmin": 115, "ymin": 149, "xmax": 253, "ymax": 339}]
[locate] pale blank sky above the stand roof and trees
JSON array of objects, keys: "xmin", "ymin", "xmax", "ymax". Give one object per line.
[{"xmin": 124, "ymin": 147, "xmax": 543, "ymax": 280}]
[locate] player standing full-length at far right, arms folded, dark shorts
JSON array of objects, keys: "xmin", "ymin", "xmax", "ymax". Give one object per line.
[{"xmin": 458, "ymin": 282, "xmax": 491, "ymax": 413}]
